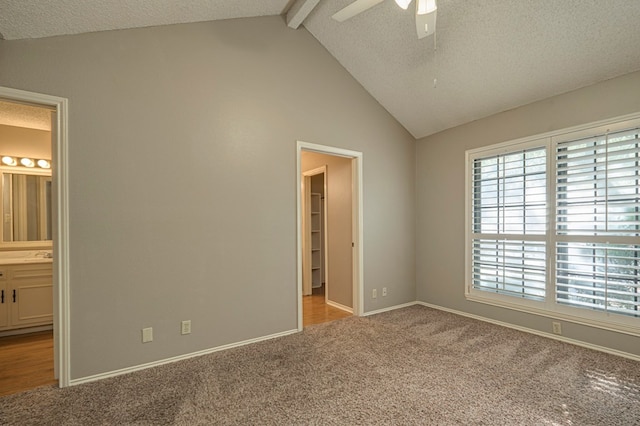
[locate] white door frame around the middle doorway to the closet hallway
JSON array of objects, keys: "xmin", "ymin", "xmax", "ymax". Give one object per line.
[{"xmin": 296, "ymin": 141, "xmax": 364, "ymax": 331}]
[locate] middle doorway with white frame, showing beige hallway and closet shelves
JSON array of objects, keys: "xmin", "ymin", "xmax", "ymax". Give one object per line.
[{"xmin": 297, "ymin": 142, "xmax": 362, "ymax": 330}]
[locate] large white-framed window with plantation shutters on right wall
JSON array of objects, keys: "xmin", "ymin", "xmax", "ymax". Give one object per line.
[{"xmin": 466, "ymin": 117, "xmax": 640, "ymax": 334}]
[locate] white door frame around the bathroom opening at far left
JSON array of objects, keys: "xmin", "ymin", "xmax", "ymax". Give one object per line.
[{"xmin": 0, "ymin": 86, "xmax": 71, "ymax": 388}]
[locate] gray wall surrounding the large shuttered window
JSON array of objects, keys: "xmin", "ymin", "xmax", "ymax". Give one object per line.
[{"xmin": 416, "ymin": 72, "xmax": 640, "ymax": 355}]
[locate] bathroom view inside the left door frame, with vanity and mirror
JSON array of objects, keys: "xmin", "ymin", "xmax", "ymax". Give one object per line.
[{"xmin": 0, "ymin": 99, "xmax": 57, "ymax": 395}]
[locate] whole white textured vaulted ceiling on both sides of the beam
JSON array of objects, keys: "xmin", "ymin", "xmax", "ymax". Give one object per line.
[{"xmin": 0, "ymin": 0, "xmax": 640, "ymax": 138}]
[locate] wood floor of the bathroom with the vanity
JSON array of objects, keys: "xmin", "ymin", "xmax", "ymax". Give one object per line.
[{"xmin": 0, "ymin": 331, "xmax": 58, "ymax": 396}]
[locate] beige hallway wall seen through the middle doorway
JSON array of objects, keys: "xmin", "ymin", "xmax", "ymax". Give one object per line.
[{"xmin": 300, "ymin": 152, "xmax": 353, "ymax": 308}]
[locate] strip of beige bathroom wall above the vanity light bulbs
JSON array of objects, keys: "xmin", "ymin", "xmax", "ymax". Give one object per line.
[{"xmin": 0, "ymin": 124, "xmax": 51, "ymax": 160}]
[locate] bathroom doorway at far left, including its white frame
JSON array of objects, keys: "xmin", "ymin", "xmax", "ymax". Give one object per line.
[{"xmin": 0, "ymin": 87, "xmax": 70, "ymax": 394}]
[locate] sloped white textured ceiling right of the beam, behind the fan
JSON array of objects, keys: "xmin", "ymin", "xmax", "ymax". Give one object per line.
[{"xmin": 304, "ymin": 0, "xmax": 640, "ymax": 138}]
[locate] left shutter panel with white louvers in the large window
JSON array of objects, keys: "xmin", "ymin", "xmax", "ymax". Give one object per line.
[{"xmin": 472, "ymin": 147, "xmax": 547, "ymax": 300}]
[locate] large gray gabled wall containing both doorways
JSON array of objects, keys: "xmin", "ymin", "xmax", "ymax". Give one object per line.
[{"xmin": 0, "ymin": 17, "xmax": 415, "ymax": 379}]
